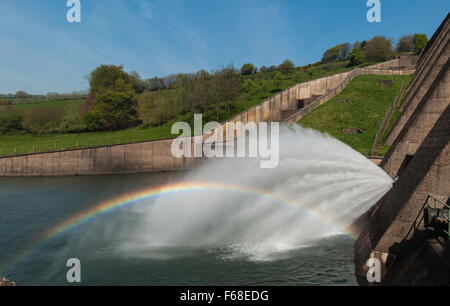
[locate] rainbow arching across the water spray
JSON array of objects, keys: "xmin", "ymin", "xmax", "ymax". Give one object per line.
[{"xmin": 3, "ymin": 182, "xmax": 355, "ymax": 274}]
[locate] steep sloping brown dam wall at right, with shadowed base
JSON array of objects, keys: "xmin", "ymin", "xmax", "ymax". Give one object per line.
[{"xmin": 355, "ymin": 11, "xmax": 450, "ymax": 285}]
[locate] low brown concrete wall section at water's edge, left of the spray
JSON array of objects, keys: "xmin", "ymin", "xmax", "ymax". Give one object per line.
[{"xmin": 0, "ymin": 139, "xmax": 201, "ymax": 176}]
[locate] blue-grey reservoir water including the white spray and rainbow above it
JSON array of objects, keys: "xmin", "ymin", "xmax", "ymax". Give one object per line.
[{"xmin": 0, "ymin": 127, "xmax": 392, "ymax": 285}]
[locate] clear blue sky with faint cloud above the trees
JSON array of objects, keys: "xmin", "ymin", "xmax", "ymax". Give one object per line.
[{"xmin": 0, "ymin": 0, "xmax": 450, "ymax": 94}]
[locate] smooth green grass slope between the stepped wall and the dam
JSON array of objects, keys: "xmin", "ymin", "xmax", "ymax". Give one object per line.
[{"xmin": 299, "ymin": 75, "xmax": 411, "ymax": 155}]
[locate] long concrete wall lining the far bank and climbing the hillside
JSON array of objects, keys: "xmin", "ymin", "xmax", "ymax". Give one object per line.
[{"xmin": 0, "ymin": 56, "xmax": 416, "ymax": 176}]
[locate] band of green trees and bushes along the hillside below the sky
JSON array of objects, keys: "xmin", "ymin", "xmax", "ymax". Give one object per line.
[{"xmin": 0, "ymin": 34, "xmax": 428, "ymax": 134}]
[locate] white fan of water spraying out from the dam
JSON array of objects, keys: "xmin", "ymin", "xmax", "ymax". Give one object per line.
[{"xmin": 121, "ymin": 125, "xmax": 392, "ymax": 260}]
